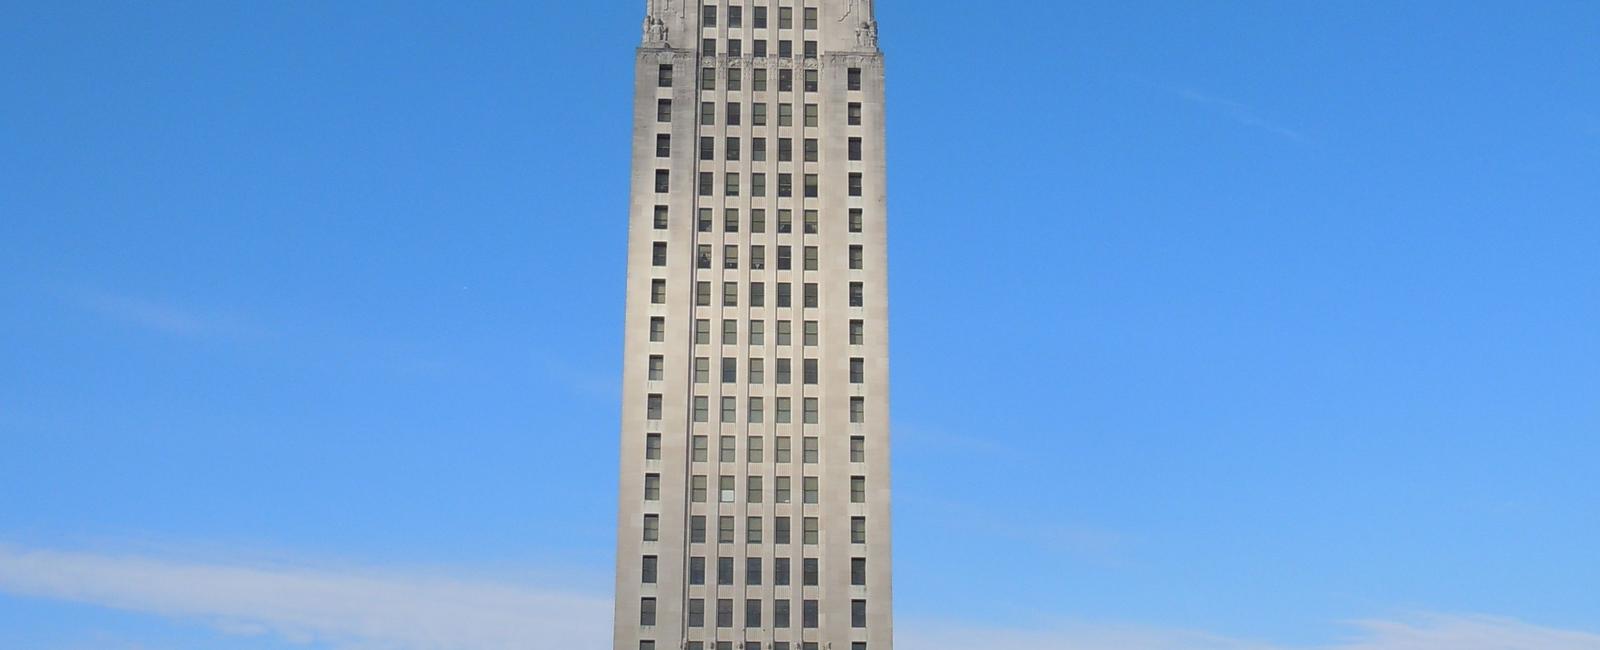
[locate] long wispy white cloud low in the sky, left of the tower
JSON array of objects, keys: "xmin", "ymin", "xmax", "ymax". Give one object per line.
[{"xmin": 0, "ymin": 546, "xmax": 611, "ymax": 650}]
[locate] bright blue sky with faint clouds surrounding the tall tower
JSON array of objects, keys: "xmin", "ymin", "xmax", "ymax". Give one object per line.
[{"xmin": 0, "ymin": 0, "xmax": 1600, "ymax": 650}]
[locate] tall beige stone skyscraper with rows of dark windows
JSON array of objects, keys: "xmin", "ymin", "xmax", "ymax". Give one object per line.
[{"xmin": 614, "ymin": 0, "xmax": 893, "ymax": 650}]
